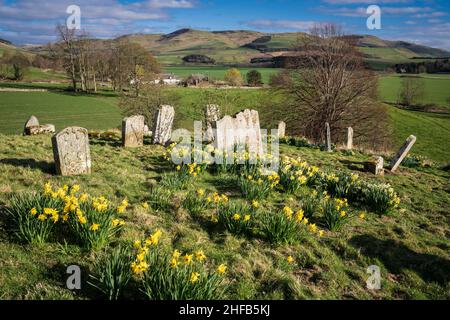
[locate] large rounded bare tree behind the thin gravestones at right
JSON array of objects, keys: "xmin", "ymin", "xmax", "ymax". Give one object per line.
[{"xmin": 274, "ymin": 24, "xmax": 387, "ymax": 149}]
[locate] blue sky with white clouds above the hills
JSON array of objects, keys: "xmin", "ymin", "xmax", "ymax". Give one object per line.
[{"xmin": 0, "ymin": 0, "xmax": 450, "ymax": 50}]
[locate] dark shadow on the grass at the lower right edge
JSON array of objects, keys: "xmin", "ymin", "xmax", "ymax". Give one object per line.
[{"xmin": 350, "ymin": 235, "xmax": 450, "ymax": 286}]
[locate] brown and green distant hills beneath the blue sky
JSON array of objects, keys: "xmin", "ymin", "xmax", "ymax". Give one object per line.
[{"xmin": 11, "ymin": 29, "xmax": 450, "ymax": 69}]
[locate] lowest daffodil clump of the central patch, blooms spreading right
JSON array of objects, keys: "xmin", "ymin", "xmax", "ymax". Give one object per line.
[{"xmin": 260, "ymin": 206, "xmax": 324, "ymax": 244}]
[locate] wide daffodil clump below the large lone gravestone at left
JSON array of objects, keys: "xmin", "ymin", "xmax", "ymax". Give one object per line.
[{"xmin": 9, "ymin": 183, "xmax": 128, "ymax": 249}]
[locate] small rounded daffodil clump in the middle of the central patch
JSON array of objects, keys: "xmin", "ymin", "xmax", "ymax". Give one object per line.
[{"xmin": 239, "ymin": 170, "xmax": 280, "ymax": 200}]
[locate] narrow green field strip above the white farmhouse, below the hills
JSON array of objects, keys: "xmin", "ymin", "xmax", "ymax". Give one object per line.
[{"xmin": 164, "ymin": 66, "xmax": 280, "ymax": 84}]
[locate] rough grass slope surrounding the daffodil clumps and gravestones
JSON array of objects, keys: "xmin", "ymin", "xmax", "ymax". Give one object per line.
[{"xmin": 0, "ymin": 136, "xmax": 450, "ymax": 299}]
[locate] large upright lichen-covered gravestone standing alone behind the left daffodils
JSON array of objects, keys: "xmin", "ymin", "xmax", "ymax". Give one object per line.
[{"xmin": 52, "ymin": 127, "xmax": 91, "ymax": 176}]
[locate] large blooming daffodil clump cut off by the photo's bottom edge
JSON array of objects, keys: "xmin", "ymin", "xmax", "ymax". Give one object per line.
[{"xmin": 131, "ymin": 230, "xmax": 227, "ymax": 300}]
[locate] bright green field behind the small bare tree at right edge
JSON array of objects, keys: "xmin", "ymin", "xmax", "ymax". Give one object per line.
[{"xmin": 379, "ymin": 74, "xmax": 450, "ymax": 108}]
